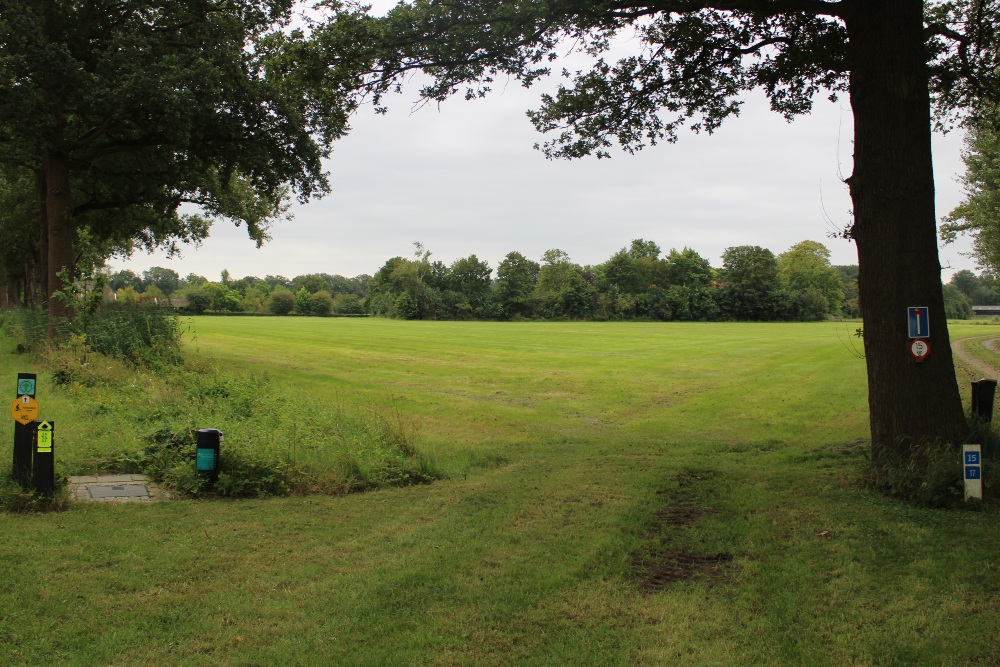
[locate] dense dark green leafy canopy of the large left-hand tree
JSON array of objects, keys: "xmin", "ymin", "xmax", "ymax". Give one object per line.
[{"xmin": 0, "ymin": 0, "xmax": 372, "ymax": 318}]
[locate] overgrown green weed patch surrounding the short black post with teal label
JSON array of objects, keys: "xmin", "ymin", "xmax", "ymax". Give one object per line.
[{"xmin": 19, "ymin": 347, "xmax": 442, "ymax": 498}]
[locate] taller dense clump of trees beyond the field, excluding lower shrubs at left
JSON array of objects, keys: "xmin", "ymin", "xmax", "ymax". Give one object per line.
[{"xmin": 368, "ymin": 239, "xmax": 857, "ymax": 321}]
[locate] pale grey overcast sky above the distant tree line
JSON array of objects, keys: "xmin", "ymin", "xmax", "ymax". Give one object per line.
[{"xmin": 110, "ymin": 8, "xmax": 975, "ymax": 281}]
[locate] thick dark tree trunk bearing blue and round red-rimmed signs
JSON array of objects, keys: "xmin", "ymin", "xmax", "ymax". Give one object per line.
[{"xmin": 847, "ymin": 0, "xmax": 967, "ymax": 465}]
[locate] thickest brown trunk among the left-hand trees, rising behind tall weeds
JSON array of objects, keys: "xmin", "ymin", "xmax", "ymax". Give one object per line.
[{"xmin": 45, "ymin": 154, "xmax": 75, "ymax": 338}]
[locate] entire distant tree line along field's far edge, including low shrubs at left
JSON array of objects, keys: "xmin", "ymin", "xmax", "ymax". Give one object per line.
[{"xmin": 108, "ymin": 239, "xmax": 872, "ymax": 321}]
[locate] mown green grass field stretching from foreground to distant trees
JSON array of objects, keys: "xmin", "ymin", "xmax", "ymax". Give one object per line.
[{"xmin": 0, "ymin": 318, "xmax": 1000, "ymax": 665}]
